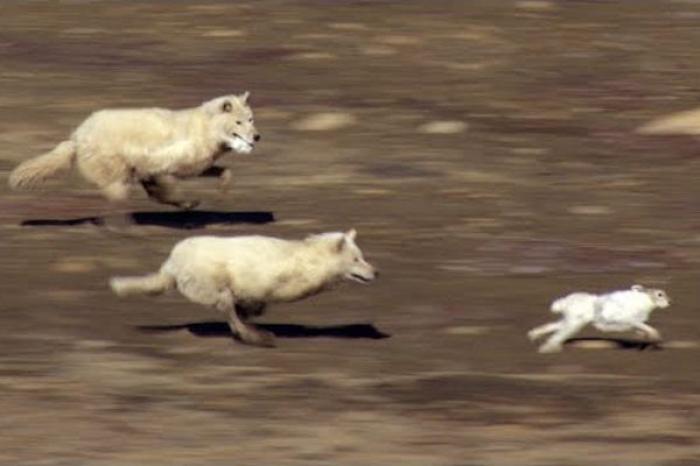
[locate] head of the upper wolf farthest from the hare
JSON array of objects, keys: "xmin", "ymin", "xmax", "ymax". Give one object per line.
[{"xmin": 203, "ymin": 92, "xmax": 260, "ymax": 154}]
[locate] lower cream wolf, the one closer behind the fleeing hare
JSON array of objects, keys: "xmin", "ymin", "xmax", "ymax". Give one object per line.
[{"xmin": 110, "ymin": 230, "xmax": 377, "ymax": 346}]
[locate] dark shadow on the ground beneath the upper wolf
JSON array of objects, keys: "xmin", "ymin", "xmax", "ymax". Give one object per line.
[{"xmin": 21, "ymin": 210, "xmax": 275, "ymax": 230}]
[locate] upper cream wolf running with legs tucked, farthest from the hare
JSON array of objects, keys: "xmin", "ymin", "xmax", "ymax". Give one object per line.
[{"xmin": 9, "ymin": 92, "xmax": 260, "ymax": 208}]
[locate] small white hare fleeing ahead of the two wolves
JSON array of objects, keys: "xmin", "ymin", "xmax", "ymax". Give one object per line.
[{"xmin": 528, "ymin": 285, "xmax": 671, "ymax": 353}]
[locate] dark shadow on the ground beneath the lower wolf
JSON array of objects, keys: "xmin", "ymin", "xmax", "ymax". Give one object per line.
[{"xmin": 136, "ymin": 321, "xmax": 391, "ymax": 340}]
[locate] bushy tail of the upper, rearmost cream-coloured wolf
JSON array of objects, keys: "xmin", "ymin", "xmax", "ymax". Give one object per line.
[{"xmin": 9, "ymin": 140, "xmax": 76, "ymax": 189}]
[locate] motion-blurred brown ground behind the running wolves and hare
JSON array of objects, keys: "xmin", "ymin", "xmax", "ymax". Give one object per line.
[{"xmin": 0, "ymin": 0, "xmax": 700, "ymax": 466}]
